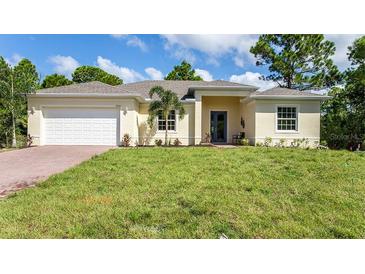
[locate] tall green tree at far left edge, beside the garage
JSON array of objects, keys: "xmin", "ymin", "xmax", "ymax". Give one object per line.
[{"xmin": 0, "ymin": 57, "xmax": 39, "ymax": 147}]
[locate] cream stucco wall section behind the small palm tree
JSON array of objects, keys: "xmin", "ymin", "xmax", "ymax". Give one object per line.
[{"xmin": 138, "ymin": 103, "xmax": 194, "ymax": 145}]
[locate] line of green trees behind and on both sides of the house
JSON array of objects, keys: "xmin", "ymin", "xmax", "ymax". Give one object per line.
[{"xmin": 0, "ymin": 34, "xmax": 365, "ymax": 150}]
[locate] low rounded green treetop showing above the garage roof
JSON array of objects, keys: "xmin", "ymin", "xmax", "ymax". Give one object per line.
[{"xmin": 72, "ymin": 66, "xmax": 123, "ymax": 86}]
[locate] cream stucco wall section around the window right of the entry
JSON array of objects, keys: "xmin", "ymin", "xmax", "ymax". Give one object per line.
[{"xmin": 255, "ymin": 100, "xmax": 320, "ymax": 145}]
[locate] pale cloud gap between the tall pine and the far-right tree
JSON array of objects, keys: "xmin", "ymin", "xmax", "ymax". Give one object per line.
[{"xmin": 325, "ymin": 34, "xmax": 362, "ymax": 70}]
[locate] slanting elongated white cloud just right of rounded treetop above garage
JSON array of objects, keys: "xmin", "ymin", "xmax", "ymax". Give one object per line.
[{"xmin": 96, "ymin": 56, "xmax": 145, "ymax": 83}]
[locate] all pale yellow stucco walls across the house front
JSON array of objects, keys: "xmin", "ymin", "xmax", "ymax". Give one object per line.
[{"xmin": 28, "ymin": 96, "xmax": 320, "ymax": 145}]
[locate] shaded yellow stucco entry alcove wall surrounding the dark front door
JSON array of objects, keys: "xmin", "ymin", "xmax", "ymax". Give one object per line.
[{"xmin": 201, "ymin": 96, "xmax": 243, "ymax": 143}]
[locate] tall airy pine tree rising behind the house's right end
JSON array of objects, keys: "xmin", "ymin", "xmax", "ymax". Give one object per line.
[{"xmin": 250, "ymin": 34, "xmax": 341, "ymax": 90}]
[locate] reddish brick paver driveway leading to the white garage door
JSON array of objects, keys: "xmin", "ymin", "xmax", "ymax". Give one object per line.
[{"xmin": 0, "ymin": 146, "xmax": 111, "ymax": 197}]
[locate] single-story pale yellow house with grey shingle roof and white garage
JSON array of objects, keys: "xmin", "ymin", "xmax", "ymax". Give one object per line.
[{"xmin": 28, "ymin": 81, "xmax": 328, "ymax": 145}]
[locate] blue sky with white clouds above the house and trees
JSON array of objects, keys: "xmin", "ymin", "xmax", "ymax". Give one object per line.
[{"xmin": 0, "ymin": 34, "xmax": 359, "ymax": 89}]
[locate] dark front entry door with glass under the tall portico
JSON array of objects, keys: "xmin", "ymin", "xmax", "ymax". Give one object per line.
[{"xmin": 210, "ymin": 111, "xmax": 227, "ymax": 143}]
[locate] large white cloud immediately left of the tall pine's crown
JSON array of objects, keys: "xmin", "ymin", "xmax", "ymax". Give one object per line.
[{"xmin": 162, "ymin": 34, "xmax": 258, "ymax": 66}]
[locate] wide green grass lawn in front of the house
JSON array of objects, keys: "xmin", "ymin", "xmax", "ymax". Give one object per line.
[{"xmin": 0, "ymin": 147, "xmax": 365, "ymax": 238}]
